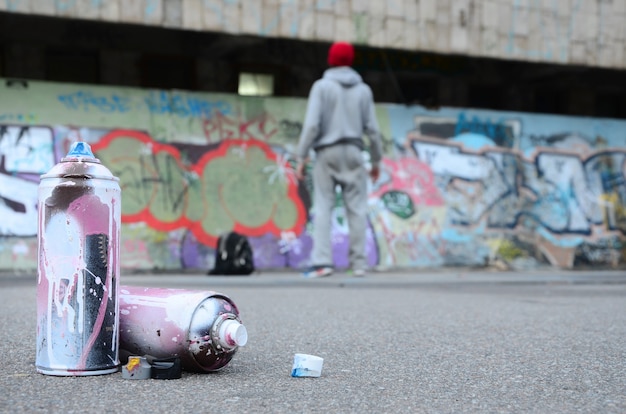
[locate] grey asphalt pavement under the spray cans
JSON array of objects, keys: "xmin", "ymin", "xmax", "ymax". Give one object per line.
[{"xmin": 0, "ymin": 269, "xmax": 626, "ymax": 413}]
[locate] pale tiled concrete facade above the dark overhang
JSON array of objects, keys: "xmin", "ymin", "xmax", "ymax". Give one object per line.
[{"xmin": 0, "ymin": 0, "xmax": 626, "ymax": 69}]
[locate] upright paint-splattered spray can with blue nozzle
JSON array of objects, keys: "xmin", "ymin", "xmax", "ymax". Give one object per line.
[{"xmin": 36, "ymin": 142, "xmax": 122, "ymax": 375}]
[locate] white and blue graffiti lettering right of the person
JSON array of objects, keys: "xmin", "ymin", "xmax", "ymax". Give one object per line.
[{"xmin": 411, "ymin": 137, "xmax": 626, "ymax": 236}]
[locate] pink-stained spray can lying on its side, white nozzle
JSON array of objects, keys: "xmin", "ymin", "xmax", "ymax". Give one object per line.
[{"xmin": 120, "ymin": 286, "xmax": 248, "ymax": 372}]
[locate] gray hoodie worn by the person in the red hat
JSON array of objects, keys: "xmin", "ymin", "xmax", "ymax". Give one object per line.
[{"xmin": 297, "ymin": 66, "xmax": 382, "ymax": 163}]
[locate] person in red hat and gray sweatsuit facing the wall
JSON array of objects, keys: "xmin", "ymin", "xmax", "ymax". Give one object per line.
[{"xmin": 296, "ymin": 42, "xmax": 382, "ymax": 277}]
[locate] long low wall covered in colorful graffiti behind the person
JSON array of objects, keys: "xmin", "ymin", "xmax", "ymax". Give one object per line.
[{"xmin": 0, "ymin": 79, "xmax": 626, "ymax": 271}]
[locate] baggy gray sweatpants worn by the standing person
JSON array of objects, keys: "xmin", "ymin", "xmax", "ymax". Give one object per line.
[{"xmin": 311, "ymin": 144, "xmax": 368, "ymax": 270}]
